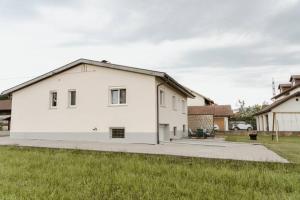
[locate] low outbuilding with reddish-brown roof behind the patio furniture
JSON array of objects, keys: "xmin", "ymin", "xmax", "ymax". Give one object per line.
[{"xmin": 188, "ymin": 105, "xmax": 233, "ymax": 131}]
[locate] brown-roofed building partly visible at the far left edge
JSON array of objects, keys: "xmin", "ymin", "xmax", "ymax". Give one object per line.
[{"xmin": 0, "ymin": 100, "xmax": 11, "ymax": 131}]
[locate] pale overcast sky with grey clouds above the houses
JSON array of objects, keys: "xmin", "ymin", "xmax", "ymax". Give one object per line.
[{"xmin": 0, "ymin": 0, "xmax": 300, "ymax": 107}]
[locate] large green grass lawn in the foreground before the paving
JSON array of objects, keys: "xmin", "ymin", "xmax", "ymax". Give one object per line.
[{"xmin": 0, "ymin": 147, "xmax": 300, "ymax": 200}]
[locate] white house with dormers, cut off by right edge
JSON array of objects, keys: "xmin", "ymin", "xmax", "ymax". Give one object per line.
[{"xmin": 255, "ymin": 75, "xmax": 300, "ymax": 132}]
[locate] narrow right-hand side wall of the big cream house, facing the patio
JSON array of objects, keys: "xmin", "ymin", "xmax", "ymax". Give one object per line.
[{"xmin": 157, "ymin": 79, "xmax": 188, "ymax": 141}]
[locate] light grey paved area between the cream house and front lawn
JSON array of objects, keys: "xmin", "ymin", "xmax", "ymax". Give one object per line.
[{"xmin": 0, "ymin": 137, "xmax": 288, "ymax": 163}]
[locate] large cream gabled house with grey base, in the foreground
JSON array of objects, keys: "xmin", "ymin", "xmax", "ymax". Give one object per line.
[{"xmin": 2, "ymin": 59, "xmax": 194, "ymax": 144}]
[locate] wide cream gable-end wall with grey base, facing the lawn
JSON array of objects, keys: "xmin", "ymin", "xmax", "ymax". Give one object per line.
[{"xmin": 11, "ymin": 65, "xmax": 158, "ymax": 143}]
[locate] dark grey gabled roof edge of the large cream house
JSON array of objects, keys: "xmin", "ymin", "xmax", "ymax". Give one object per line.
[{"xmin": 1, "ymin": 58, "xmax": 194, "ymax": 98}]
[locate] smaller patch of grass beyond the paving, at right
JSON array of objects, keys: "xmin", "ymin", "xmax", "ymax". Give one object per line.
[{"xmin": 225, "ymin": 135, "xmax": 300, "ymax": 164}]
